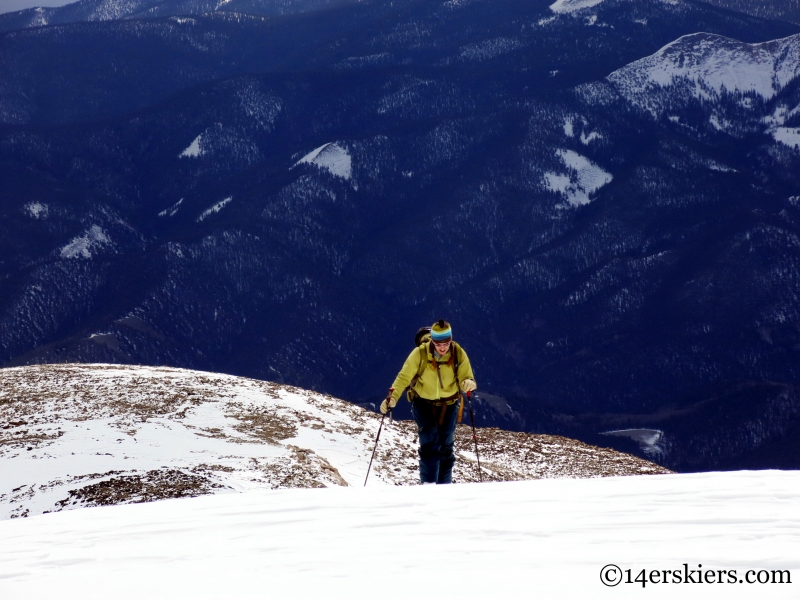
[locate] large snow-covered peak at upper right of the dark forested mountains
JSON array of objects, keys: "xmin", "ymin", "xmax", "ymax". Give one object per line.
[{"xmin": 607, "ymin": 33, "xmax": 800, "ymax": 112}]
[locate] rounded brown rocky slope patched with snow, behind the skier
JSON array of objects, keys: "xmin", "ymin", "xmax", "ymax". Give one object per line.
[{"xmin": 0, "ymin": 365, "xmax": 667, "ymax": 518}]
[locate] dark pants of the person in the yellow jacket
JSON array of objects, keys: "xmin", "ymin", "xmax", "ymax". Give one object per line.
[{"xmin": 411, "ymin": 398, "xmax": 458, "ymax": 483}]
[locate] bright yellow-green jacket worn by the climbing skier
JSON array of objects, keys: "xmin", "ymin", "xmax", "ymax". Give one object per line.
[{"xmin": 392, "ymin": 342, "xmax": 475, "ymax": 404}]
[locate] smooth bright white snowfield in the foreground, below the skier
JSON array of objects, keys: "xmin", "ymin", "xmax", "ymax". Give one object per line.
[{"xmin": 0, "ymin": 471, "xmax": 800, "ymax": 600}]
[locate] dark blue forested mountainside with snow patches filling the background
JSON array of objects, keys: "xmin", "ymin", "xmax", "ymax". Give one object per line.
[{"xmin": 0, "ymin": 0, "xmax": 800, "ymax": 470}]
